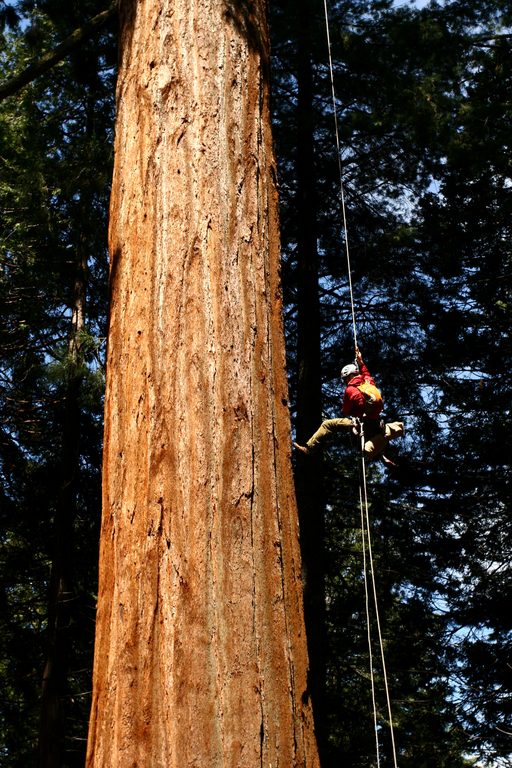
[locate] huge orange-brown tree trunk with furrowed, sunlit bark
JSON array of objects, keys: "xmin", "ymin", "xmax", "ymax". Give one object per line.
[{"xmin": 87, "ymin": 0, "xmax": 318, "ymax": 768}]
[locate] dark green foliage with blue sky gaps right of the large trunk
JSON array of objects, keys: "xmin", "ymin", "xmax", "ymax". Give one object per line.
[{"xmin": 274, "ymin": 2, "xmax": 512, "ymax": 767}]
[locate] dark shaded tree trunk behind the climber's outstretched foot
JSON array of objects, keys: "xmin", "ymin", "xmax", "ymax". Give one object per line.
[{"xmin": 296, "ymin": 0, "xmax": 327, "ymax": 762}]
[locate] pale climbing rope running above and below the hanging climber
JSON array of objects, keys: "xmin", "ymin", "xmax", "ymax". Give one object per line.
[{"xmin": 324, "ymin": 0, "xmax": 398, "ymax": 768}]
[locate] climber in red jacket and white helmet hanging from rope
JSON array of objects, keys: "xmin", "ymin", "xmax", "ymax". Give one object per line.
[{"xmin": 294, "ymin": 348, "xmax": 404, "ymax": 468}]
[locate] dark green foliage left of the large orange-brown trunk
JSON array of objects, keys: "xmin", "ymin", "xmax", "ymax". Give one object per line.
[{"xmin": 0, "ymin": 2, "xmax": 115, "ymax": 766}]
